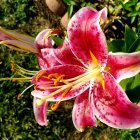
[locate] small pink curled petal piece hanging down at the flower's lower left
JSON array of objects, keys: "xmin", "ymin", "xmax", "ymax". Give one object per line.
[{"xmin": 33, "ymin": 97, "xmax": 48, "ymax": 126}]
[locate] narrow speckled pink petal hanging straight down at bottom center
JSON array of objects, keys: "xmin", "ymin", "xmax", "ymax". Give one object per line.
[{"xmin": 72, "ymin": 90, "xmax": 96, "ymax": 132}]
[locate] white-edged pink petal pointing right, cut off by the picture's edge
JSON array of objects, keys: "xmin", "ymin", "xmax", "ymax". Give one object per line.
[{"xmin": 107, "ymin": 52, "xmax": 140, "ymax": 82}]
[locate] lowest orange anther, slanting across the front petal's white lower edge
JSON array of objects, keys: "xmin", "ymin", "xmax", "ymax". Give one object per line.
[{"xmin": 51, "ymin": 86, "xmax": 72, "ymax": 111}]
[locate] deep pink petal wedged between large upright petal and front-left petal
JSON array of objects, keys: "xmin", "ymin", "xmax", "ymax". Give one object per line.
[{"xmin": 53, "ymin": 39, "xmax": 82, "ymax": 66}]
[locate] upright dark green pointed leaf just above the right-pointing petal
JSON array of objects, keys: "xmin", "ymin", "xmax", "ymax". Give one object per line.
[{"xmin": 124, "ymin": 26, "xmax": 137, "ymax": 52}]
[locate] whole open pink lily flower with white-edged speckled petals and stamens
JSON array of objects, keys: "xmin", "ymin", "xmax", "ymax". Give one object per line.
[{"xmin": 32, "ymin": 7, "xmax": 140, "ymax": 131}]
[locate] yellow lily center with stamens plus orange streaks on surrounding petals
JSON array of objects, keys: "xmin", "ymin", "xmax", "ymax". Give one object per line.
[{"xmin": 36, "ymin": 52, "xmax": 104, "ymax": 107}]
